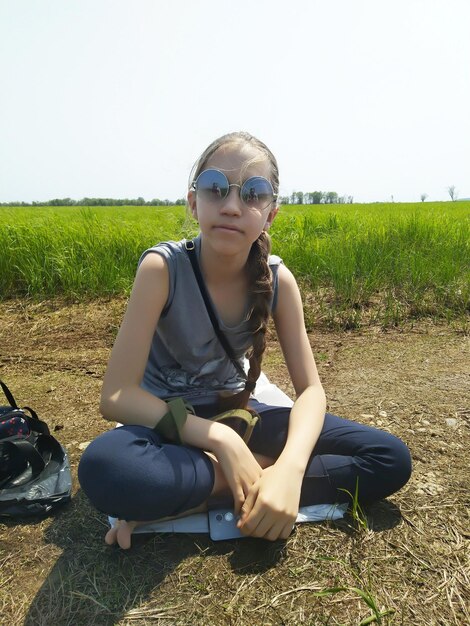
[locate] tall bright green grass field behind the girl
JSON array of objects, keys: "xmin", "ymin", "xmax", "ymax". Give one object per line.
[{"xmin": 0, "ymin": 202, "xmax": 470, "ymax": 327}]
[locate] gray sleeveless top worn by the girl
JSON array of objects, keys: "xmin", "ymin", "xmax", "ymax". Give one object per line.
[{"xmin": 139, "ymin": 237, "xmax": 282, "ymax": 405}]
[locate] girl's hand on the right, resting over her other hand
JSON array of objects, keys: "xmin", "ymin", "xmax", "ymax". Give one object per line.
[{"xmin": 238, "ymin": 464, "xmax": 303, "ymax": 541}]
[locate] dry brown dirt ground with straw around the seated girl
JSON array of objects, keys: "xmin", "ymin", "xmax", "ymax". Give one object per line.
[{"xmin": 0, "ymin": 300, "xmax": 470, "ymax": 626}]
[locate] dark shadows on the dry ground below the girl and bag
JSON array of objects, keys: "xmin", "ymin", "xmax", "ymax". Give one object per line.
[{"xmin": 0, "ymin": 490, "xmax": 402, "ymax": 626}]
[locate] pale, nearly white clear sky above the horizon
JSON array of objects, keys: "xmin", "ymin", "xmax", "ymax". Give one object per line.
[{"xmin": 0, "ymin": 0, "xmax": 470, "ymax": 202}]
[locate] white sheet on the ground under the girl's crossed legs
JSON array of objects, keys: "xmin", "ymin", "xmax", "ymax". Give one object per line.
[{"xmin": 108, "ymin": 504, "xmax": 348, "ymax": 534}]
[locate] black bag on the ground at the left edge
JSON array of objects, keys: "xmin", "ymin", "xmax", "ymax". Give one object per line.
[{"xmin": 0, "ymin": 380, "xmax": 72, "ymax": 517}]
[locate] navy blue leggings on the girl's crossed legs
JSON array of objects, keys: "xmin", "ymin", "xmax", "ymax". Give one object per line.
[{"xmin": 78, "ymin": 401, "xmax": 411, "ymax": 521}]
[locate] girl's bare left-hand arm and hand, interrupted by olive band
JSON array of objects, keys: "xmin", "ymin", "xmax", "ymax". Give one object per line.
[{"xmin": 100, "ymin": 254, "xmax": 261, "ymax": 508}]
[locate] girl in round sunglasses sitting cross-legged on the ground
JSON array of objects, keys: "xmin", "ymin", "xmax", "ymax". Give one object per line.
[{"xmin": 79, "ymin": 133, "xmax": 411, "ymax": 548}]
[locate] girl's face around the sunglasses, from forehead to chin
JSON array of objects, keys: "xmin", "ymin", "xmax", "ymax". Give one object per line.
[{"xmin": 188, "ymin": 144, "xmax": 278, "ymax": 254}]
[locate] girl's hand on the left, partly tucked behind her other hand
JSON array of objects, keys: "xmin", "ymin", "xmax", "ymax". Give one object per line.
[{"xmin": 212, "ymin": 426, "xmax": 263, "ymax": 515}]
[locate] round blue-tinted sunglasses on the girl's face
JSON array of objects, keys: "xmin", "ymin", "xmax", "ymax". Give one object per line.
[{"xmin": 191, "ymin": 168, "xmax": 277, "ymax": 211}]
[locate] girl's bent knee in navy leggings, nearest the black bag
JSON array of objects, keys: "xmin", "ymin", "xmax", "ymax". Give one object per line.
[{"xmin": 78, "ymin": 426, "xmax": 214, "ymax": 521}]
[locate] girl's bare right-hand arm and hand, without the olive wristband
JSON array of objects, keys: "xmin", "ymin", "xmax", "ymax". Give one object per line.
[{"xmin": 239, "ymin": 265, "xmax": 326, "ymax": 540}]
